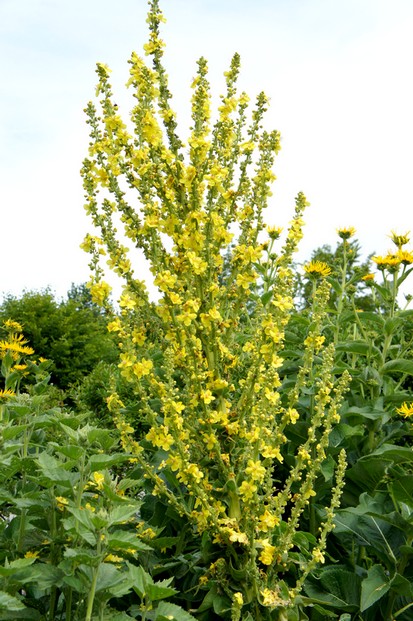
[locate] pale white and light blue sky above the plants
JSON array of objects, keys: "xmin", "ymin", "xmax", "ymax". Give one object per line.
[{"xmin": 0, "ymin": 0, "xmax": 413, "ymax": 296}]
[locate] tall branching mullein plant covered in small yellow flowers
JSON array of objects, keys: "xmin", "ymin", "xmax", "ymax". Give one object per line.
[{"xmin": 82, "ymin": 0, "xmax": 347, "ymax": 619}]
